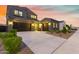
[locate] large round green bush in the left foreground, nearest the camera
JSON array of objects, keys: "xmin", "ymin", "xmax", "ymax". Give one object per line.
[{"xmin": 3, "ymin": 37, "xmax": 22, "ymax": 54}]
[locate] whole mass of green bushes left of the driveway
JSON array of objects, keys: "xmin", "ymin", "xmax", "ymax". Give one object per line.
[{"xmin": 0, "ymin": 29, "xmax": 22, "ymax": 54}]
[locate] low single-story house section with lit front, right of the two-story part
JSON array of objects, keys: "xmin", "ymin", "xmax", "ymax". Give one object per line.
[{"xmin": 41, "ymin": 18, "xmax": 65, "ymax": 30}]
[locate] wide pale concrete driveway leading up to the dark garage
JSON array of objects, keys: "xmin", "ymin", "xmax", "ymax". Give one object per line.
[{"xmin": 17, "ymin": 31, "xmax": 66, "ymax": 54}]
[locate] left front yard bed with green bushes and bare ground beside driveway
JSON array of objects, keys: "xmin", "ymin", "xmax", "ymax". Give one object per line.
[{"xmin": 0, "ymin": 30, "xmax": 33, "ymax": 54}]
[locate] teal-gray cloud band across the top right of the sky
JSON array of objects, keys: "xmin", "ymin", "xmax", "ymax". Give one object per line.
[{"xmin": 40, "ymin": 5, "xmax": 79, "ymax": 13}]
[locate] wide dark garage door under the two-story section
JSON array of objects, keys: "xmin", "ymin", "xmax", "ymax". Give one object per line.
[{"xmin": 13, "ymin": 22, "xmax": 31, "ymax": 31}]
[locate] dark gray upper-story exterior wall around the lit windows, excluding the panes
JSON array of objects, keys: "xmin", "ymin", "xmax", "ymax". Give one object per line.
[{"xmin": 6, "ymin": 5, "xmax": 37, "ymax": 20}]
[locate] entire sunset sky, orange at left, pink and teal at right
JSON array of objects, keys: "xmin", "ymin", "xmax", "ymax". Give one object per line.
[{"xmin": 0, "ymin": 5, "xmax": 79, "ymax": 27}]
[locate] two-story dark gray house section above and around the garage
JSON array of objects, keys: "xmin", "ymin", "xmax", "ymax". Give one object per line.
[{"xmin": 0, "ymin": 5, "xmax": 37, "ymax": 31}]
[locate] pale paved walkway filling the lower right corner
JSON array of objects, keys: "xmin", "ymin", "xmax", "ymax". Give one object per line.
[{"xmin": 54, "ymin": 30, "xmax": 79, "ymax": 54}]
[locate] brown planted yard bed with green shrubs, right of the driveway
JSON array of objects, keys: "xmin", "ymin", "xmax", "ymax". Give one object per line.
[{"xmin": 47, "ymin": 25, "xmax": 77, "ymax": 39}]
